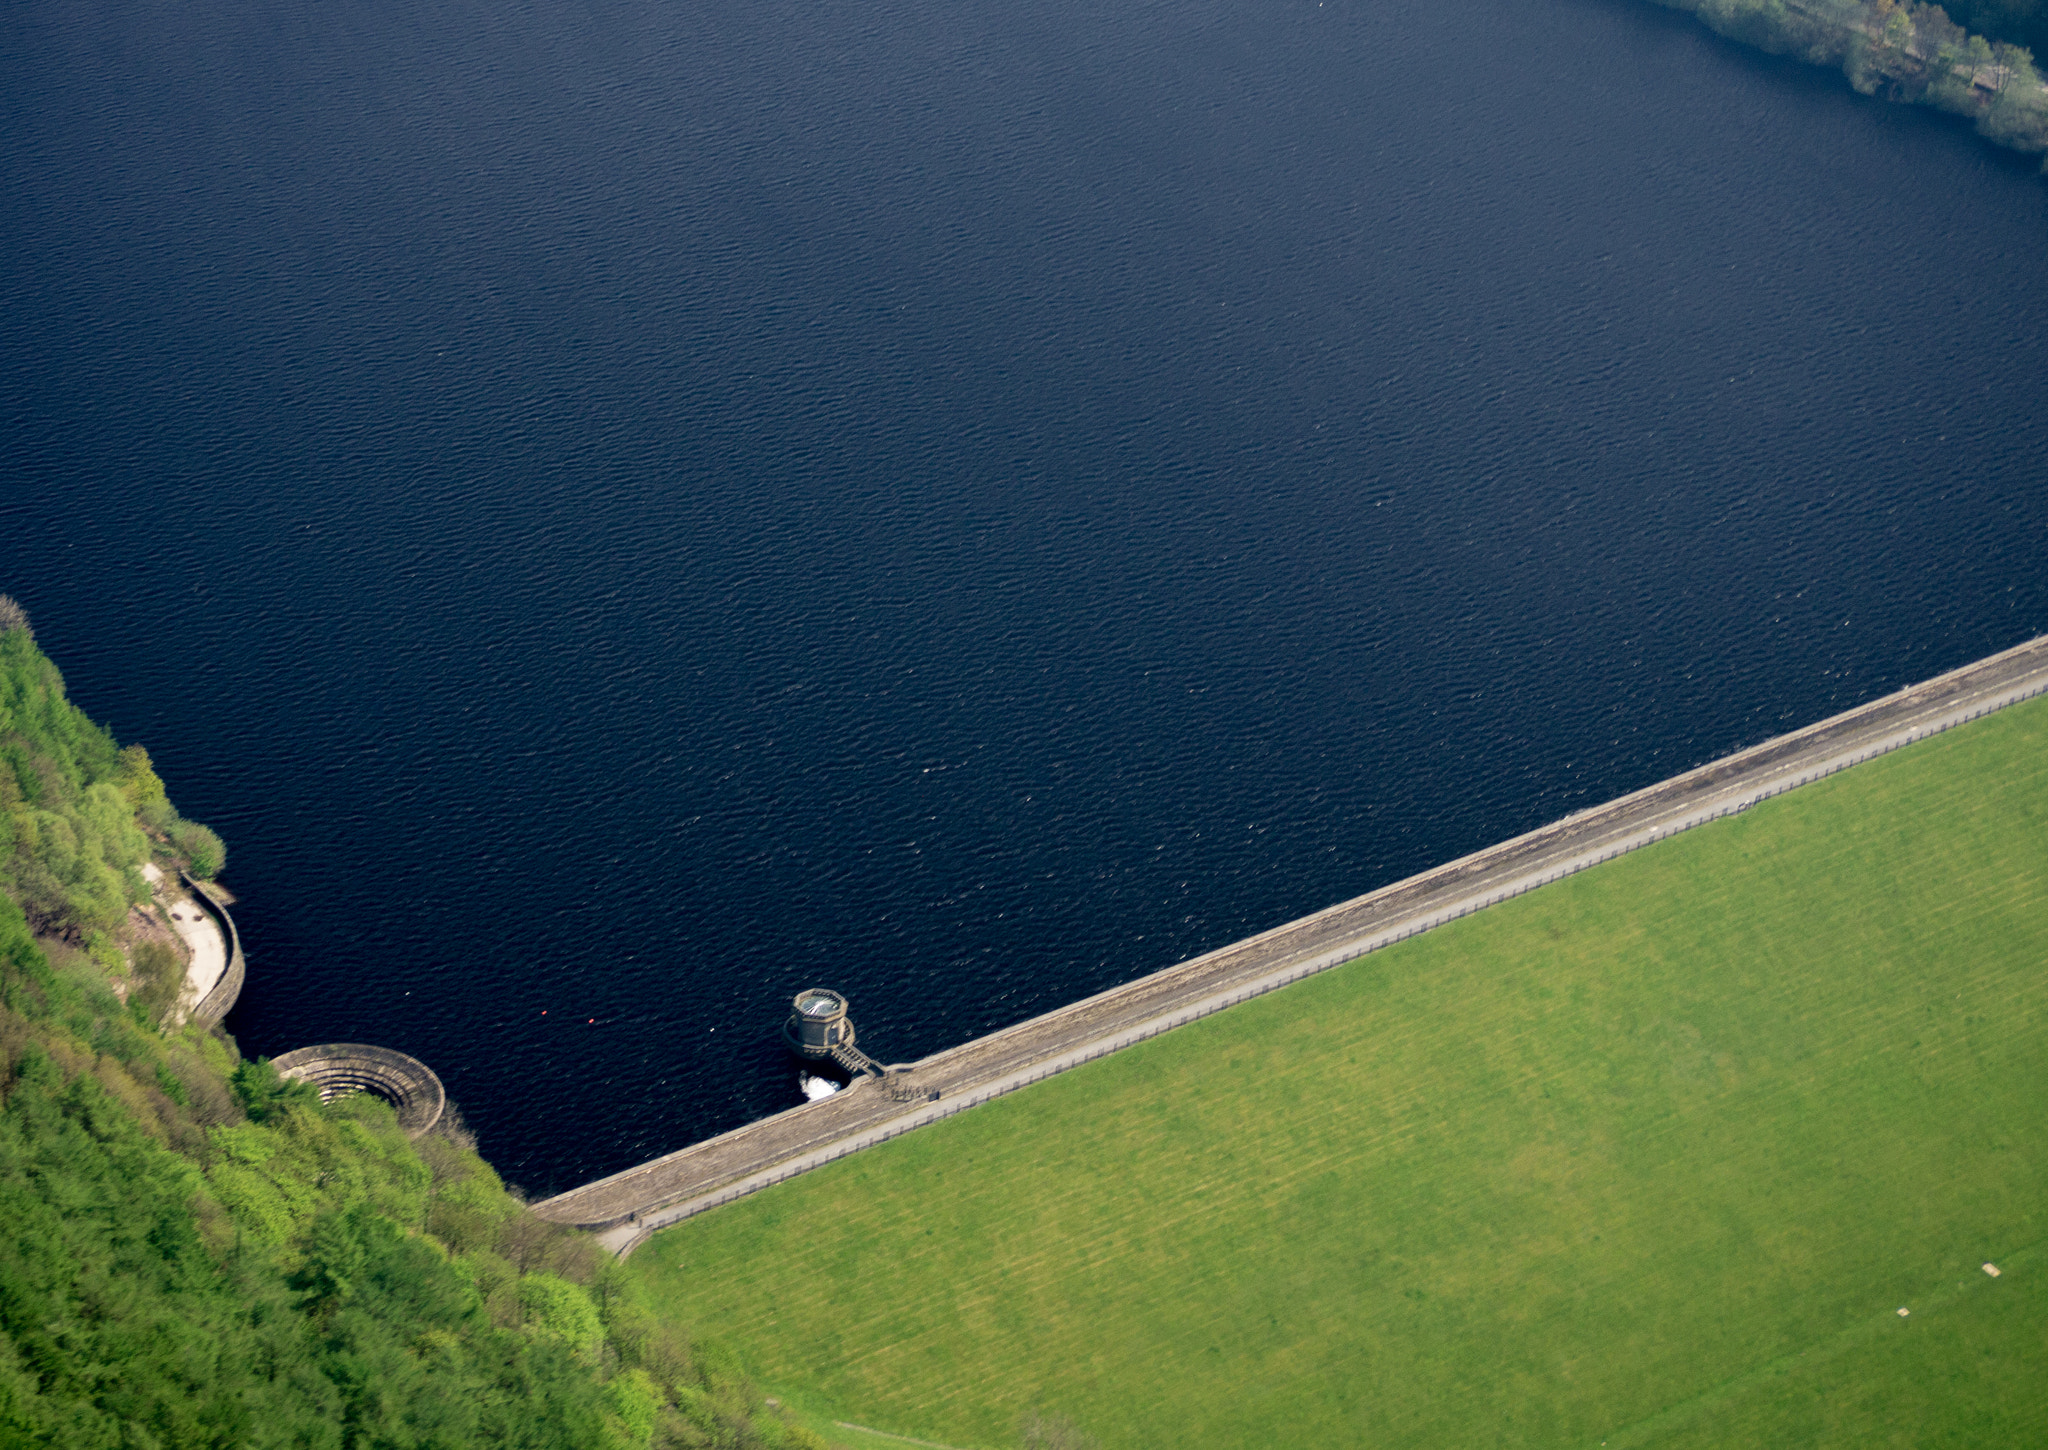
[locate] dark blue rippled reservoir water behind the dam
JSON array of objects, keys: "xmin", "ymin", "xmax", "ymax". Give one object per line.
[{"xmin": 0, "ymin": 0, "xmax": 2048, "ymax": 1192}]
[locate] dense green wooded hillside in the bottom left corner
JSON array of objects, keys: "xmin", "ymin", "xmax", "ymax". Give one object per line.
[{"xmin": 0, "ymin": 630, "xmax": 839, "ymax": 1450}]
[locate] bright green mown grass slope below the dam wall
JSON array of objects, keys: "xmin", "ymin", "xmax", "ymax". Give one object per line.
[{"xmin": 631, "ymin": 702, "xmax": 2048, "ymax": 1450}]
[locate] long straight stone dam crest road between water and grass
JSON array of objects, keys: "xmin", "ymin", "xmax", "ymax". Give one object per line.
[{"xmin": 532, "ymin": 635, "xmax": 2048, "ymax": 1253}]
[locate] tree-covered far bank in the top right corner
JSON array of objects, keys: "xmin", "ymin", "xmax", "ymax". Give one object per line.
[{"xmin": 1655, "ymin": 0, "xmax": 2048, "ymax": 162}]
